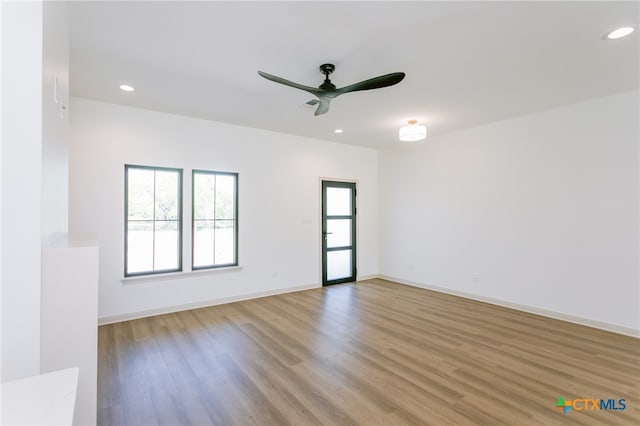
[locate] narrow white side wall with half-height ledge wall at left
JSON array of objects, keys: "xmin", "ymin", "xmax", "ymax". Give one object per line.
[{"xmin": 40, "ymin": 2, "xmax": 98, "ymax": 425}]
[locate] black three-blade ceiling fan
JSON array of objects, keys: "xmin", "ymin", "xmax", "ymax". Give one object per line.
[{"xmin": 258, "ymin": 64, "xmax": 405, "ymax": 115}]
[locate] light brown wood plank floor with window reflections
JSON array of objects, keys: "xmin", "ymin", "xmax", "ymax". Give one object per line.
[{"xmin": 98, "ymin": 279, "xmax": 640, "ymax": 426}]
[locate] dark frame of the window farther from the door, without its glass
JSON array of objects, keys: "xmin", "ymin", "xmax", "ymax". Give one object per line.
[{"xmin": 124, "ymin": 164, "xmax": 184, "ymax": 278}]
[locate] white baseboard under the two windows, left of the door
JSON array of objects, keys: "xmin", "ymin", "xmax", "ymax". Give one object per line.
[{"xmin": 98, "ymin": 284, "xmax": 320, "ymax": 326}]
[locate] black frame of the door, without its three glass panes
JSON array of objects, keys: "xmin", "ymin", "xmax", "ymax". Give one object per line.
[{"xmin": 321, "ymin": 179, "xmax": 358, "ymax": 286}]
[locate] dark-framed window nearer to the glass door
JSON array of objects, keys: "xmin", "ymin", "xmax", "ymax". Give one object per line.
[{"xmin": 192, "ymin": 170, "xmax": 238, "ymax": 269}]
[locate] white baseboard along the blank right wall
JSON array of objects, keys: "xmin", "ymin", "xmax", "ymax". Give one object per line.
[{"xmin": 378, "ymin": 275, "xmax": 640, "ymax": 338}]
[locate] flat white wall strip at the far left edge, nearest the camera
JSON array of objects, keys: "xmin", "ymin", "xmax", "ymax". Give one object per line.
[{"xmin": 1, "ymin": 1, "xmax": 43, "ymax": 382}]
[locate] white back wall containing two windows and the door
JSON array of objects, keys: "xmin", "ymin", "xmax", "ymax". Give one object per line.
[{"xmin": 69, "ymin": 98, "xmax": 378, "ymax": 322}]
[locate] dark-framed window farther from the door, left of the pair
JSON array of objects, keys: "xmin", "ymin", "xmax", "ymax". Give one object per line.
[{"xmin": 124, "ymin": 165, "xmax": 182, "ymax": 276}]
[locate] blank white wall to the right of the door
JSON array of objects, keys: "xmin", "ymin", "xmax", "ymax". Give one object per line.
[{"xmin": 379, "ymin": 91, "xmax": 640, "ymax": 334}]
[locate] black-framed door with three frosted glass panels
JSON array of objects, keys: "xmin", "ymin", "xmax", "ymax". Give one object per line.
[{"xmin": 322, "ymin": 181, "xmax": 356, "ymax": 285}]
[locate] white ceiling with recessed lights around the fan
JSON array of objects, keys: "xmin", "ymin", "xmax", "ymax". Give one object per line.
[{"xmin": 70, "ymin": 1, "xmax": 640, "ymax": 147}]
